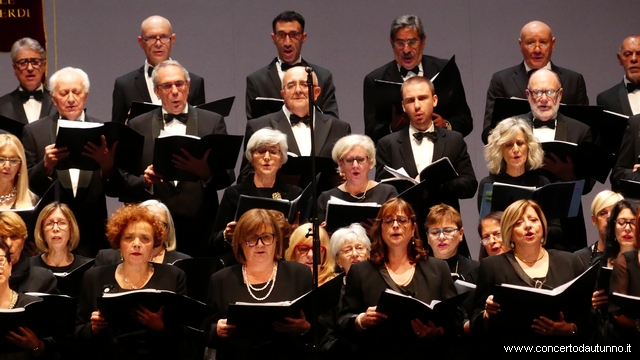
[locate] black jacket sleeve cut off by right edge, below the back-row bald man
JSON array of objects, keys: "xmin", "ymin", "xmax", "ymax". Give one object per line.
[{"xmin": 610, "ymin": 114, "xmax": 640, "ymax": 191}]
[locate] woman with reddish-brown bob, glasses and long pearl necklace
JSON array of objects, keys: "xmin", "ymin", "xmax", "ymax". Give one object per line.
[{"xmin": 206, "ymin": 209, "xmax": 313, "ymax": 360}]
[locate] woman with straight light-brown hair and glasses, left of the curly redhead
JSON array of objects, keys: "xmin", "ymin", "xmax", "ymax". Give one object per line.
[{"xmin": 29, "ymin": 202, "xmax": 91, "ymax": 273}]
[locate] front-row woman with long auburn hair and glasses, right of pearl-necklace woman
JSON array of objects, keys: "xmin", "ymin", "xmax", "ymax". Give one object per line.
[{"xmin": 338, "ymin": 198, "xmax": 462, "ymax": 359}]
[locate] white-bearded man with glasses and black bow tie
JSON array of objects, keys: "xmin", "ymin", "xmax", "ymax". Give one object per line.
[{"xmin": 523, "ymin": 69, "xmax": 594, "ymax": 252}]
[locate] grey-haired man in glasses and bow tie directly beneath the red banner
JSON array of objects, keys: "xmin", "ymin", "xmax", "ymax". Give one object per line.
[{"xmin": 0, "ymin": 38, "xmax": 56, "ymax": 125}]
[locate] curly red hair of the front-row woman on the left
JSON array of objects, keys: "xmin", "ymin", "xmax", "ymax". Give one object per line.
[{"xmin": 107, "ymin": 204, "xmax": 165, "ymax": 249}]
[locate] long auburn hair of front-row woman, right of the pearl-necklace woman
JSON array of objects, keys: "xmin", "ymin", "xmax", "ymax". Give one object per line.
[{"xmin": 369, "ymin": 198, "xmax": 427, "ymax": 264}]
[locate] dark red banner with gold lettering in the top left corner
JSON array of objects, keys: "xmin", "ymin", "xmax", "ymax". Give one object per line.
[{"xmin": 0, "ymin": 0, "xmax": 47, "ymax": 52}]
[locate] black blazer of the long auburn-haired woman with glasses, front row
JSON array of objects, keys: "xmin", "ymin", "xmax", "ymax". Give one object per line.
[{"xmin": 338, "ymin": 258, "xmax": 457, "ymax": 359}]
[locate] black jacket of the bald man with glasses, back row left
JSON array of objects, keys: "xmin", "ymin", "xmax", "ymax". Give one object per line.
[{"xmin": 111, "ymin": 65, "xmax": 205, "ymax": 123}]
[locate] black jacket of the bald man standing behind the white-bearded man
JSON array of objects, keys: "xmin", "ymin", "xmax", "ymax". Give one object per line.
[{"xmin": 482, "ymin": 62, "xmax": 589, "ymax": 144}]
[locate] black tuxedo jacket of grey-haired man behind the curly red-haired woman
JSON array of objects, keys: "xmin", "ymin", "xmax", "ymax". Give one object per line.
[{"xmin": 108, "ymin": 106, "xmax": 234, "ymax": 256}]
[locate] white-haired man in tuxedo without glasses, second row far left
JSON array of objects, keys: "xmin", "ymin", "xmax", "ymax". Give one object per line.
[{"xmin": 22, "ymin": 67, "xmax": 115, "ymax": 257}]
